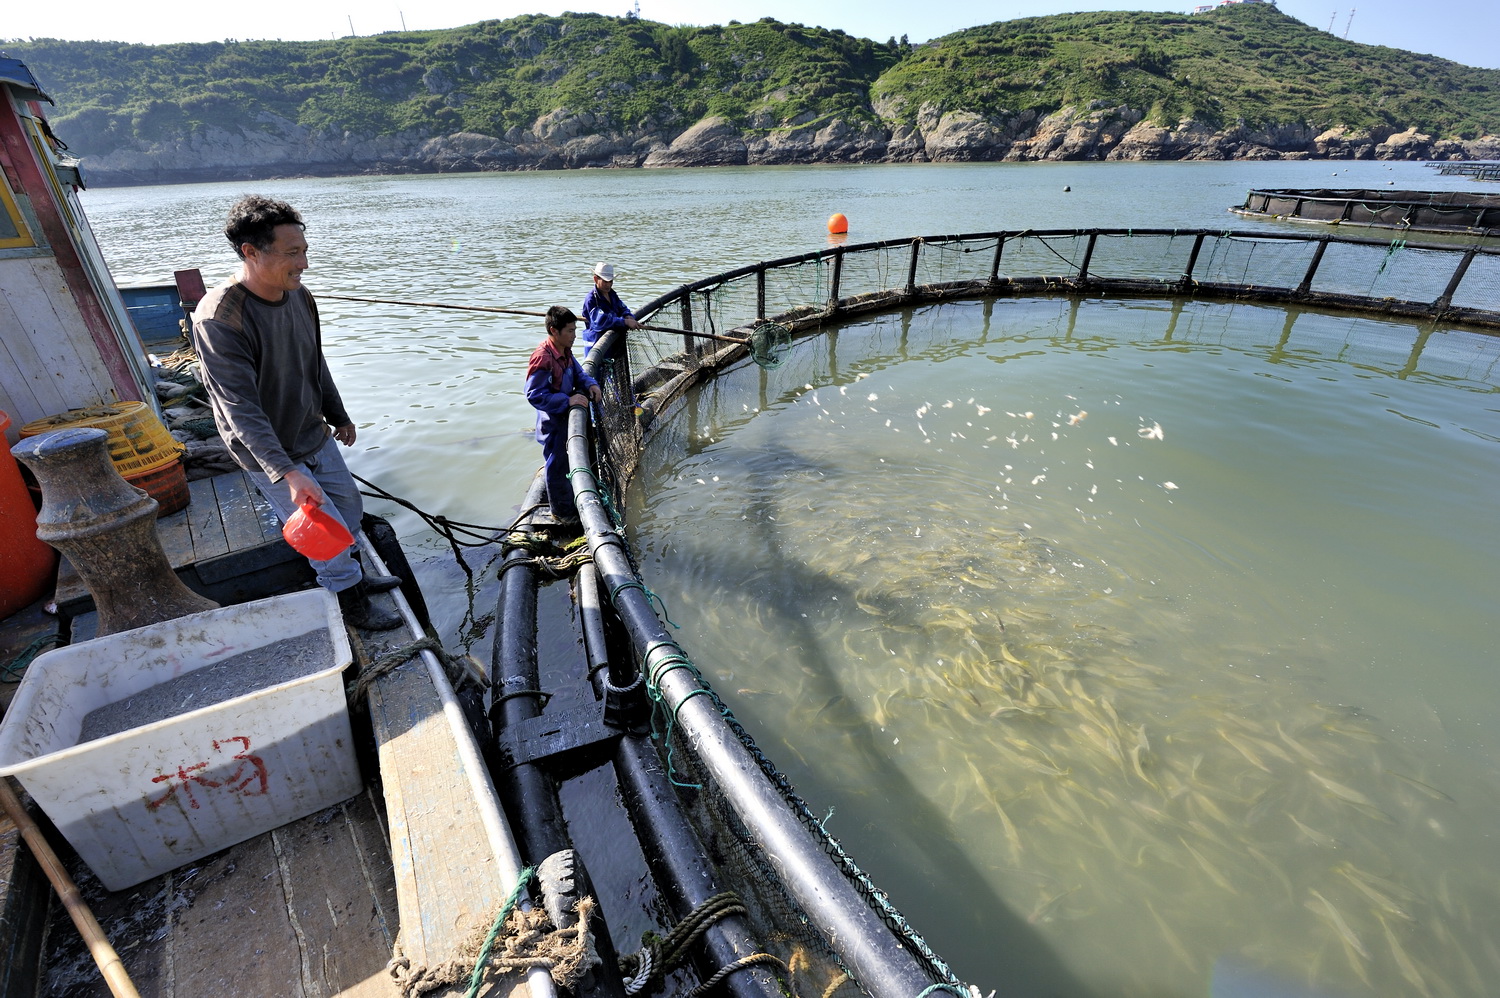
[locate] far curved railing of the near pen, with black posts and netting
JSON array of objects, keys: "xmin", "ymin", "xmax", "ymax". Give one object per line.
[{"xmin": 612, "ymin": 228, "xmax": 1500, "ymax": 402}]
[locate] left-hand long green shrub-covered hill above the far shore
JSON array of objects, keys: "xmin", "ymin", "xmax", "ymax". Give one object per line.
[{"xmin": 5, "ymin": 14, "xmax": 899, "ymax": 155}]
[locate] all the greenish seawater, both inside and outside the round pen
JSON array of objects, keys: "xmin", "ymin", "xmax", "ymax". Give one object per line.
[{"xmin": 84, "ymin": 164, "xmax": 1500, "ymax": 996}]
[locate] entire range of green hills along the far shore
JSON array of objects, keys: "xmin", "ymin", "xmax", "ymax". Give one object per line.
[{"xmin": 0, "ymin": 3, "xmax": 1500, "ymax": 176}]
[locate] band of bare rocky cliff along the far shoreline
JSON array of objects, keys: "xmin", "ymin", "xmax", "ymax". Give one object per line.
[{"xmin": 79, "ymin": 102, "xmax": 1500, "ymax": 186}]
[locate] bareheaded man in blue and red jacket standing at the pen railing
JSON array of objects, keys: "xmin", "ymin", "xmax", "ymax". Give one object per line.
[{"xmin": 527, "ymin": 305, "xmax": 605, "ymax": 527}]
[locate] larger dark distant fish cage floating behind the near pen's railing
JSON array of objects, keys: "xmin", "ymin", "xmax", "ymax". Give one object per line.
[{"xmin": 1230, "ymin": 189, "xmax": 1500, "ymax": 236}]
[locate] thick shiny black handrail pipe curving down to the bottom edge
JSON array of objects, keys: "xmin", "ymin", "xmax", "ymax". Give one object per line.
[{"xmin": 567, "ymin": 402, "xmax": 939, "ymax": 998}]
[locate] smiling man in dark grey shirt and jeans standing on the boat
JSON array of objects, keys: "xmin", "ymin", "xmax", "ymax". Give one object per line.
[{"xmin": 192, "ymin": 195, "xmax": 401, "ymax": 630}]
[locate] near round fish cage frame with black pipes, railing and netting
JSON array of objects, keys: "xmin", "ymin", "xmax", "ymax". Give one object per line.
[{"xmin": 504, "ymin": 230, "xmax": 1500, "ymax": 998}]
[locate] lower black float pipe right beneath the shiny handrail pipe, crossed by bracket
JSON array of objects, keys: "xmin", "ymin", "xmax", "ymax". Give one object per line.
[{"xmin": 578, "ymin": 566, "xmax": 782, "ymax": 998}]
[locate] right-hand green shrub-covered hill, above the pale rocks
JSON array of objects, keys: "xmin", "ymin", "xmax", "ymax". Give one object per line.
[{"xmin": 873, "ymin": 3, "xmax": 1500, "ymax": 138}]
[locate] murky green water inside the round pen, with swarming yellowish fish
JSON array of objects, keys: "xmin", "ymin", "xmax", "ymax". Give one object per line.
[{"xmin": 630, "ymin": 300, "xmax": 1500, "ymax": 996}]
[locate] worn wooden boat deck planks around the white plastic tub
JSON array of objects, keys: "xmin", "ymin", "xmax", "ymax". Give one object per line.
[{"xmin": 0, "ymin": 474, "xmax": 551, "ymax": 998}]
